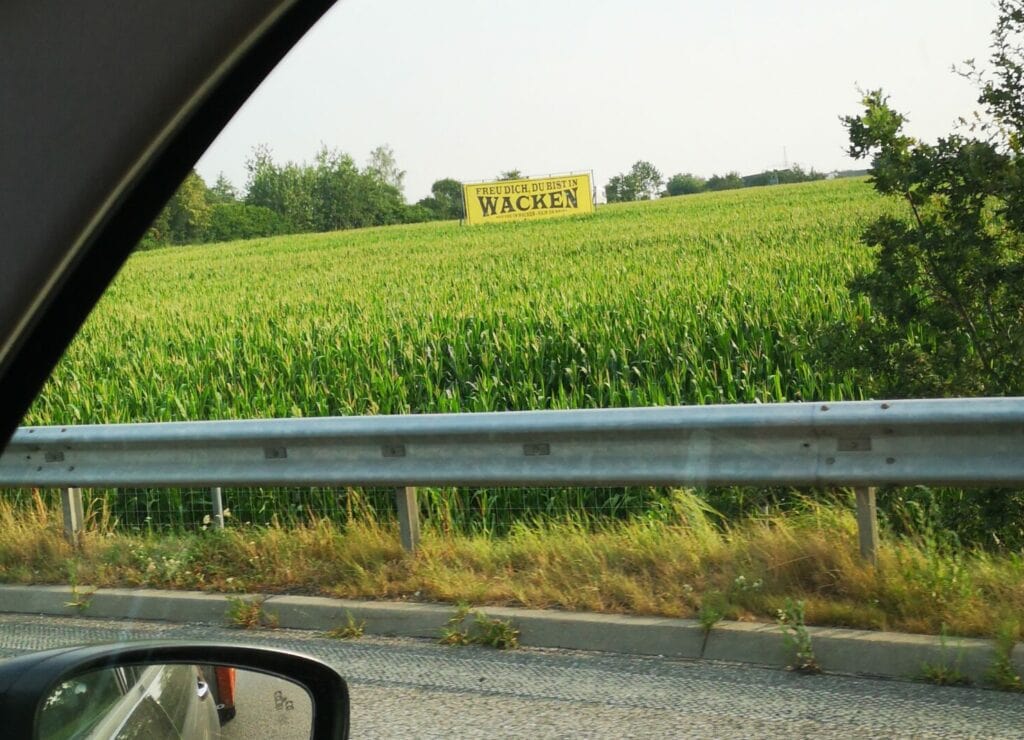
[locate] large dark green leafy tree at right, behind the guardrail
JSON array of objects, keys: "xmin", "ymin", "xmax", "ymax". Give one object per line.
[{"xmin": 834, "ymin": 0, "xmax": 1024, "ymax": 396}]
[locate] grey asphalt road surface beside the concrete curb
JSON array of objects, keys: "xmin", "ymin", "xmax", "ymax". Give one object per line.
[{"xmin": 0, "ymin": 614, "xmax": 1024, "ymax": 738}]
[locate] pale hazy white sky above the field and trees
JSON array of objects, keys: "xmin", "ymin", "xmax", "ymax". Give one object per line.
[{"xmin": 198, "ymin": 0, "xmax": 995, "ymax": 203}]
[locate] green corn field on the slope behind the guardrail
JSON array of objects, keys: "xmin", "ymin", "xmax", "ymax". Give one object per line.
[{"xmin": 14, "ymin": 180, "xmax": 896, "ymax": 528}]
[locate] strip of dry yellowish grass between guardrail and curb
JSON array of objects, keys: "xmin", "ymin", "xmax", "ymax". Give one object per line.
[{"xmin": 0, "ymin": 491, "xmax": 1024, "ymax": 636}]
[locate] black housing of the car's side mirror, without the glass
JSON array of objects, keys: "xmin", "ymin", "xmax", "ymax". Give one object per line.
[{"xmin": 0, "ymin": 642, "xmax": 349, "ymax": 740}]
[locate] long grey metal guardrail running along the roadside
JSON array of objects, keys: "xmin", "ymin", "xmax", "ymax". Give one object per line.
[{"xmin": 0, "ymin": 398, "xmax": 1024, "ymax": 556}]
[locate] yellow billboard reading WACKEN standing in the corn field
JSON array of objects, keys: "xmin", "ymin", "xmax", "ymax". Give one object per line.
[{"xmin": 462, "ymin": 173, "xmax": 594, "ymax": 224}]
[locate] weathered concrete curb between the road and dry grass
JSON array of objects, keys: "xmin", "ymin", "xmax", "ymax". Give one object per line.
[{"xmin": 0, "ymin": 585, "xmax": 1024, "ymax": 684}]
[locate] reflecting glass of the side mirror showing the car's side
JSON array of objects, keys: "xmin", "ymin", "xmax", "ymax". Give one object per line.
[{"xmin": 38, "ymin": 663, "xmax": 313, "ymax": 740}]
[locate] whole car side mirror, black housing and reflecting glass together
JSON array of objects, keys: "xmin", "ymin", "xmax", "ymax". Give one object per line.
[{"xmin": 0, "ymin": 642, "xmax": 349, "ymax": 740}]
